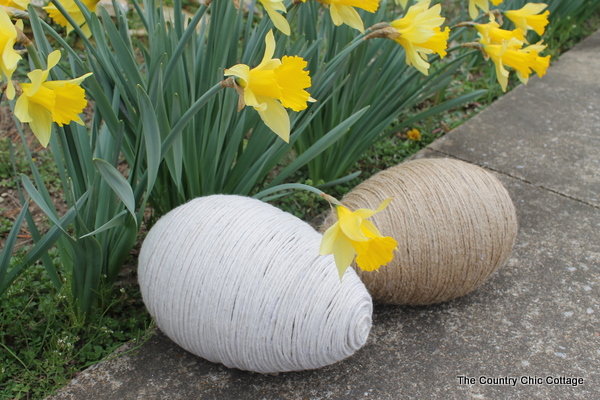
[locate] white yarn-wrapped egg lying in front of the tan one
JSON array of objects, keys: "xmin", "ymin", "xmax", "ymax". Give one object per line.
[{"xmin": 138, "ymin": 195, "xmax": 373, "ymax": 373}]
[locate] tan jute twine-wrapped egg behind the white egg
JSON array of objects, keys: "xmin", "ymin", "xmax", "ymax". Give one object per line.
[{"xmin": 320, "ymin": 159, "xmax": 517, "ymax": 305}]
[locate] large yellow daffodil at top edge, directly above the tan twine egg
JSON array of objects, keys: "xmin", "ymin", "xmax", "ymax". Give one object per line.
[{"xmin": 388, "ymin": 0, "xmax": 450, "ymax": 75}]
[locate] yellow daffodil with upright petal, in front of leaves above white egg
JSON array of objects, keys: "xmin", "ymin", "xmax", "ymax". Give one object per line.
[{"xmin": 225, "ymin": 31, "xmax": 315, "ymax": 142}]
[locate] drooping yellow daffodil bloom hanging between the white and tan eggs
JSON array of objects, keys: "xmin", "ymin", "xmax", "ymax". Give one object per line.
[{"xmin": 320, "ymin": 198, "xmax": 398, "ymax": 280}]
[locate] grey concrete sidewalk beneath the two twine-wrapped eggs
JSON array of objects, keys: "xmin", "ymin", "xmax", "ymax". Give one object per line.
[{"xmin": 52, "ymin": 31, "xmax": 600, "ymax": 400}]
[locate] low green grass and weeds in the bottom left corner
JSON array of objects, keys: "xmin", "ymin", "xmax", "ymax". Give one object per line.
[{"xmin": 0, "ymin": 250, "xmax": 151, "ymax": 399}]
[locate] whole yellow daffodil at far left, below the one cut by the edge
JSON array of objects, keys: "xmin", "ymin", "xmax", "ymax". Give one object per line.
[{"xmin": 15, "ymin": 50, "xmax": 91, "ymax": 147}]
